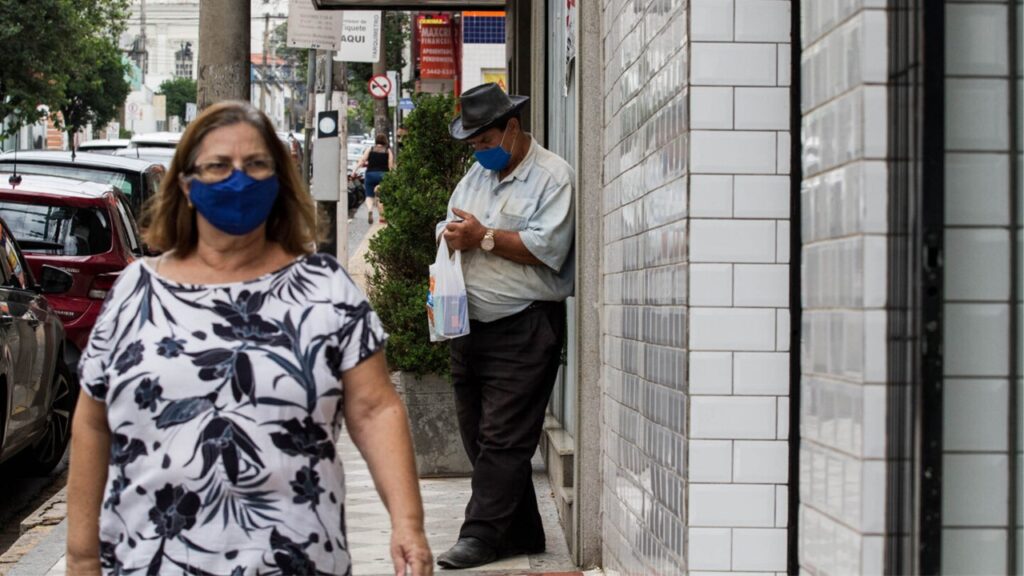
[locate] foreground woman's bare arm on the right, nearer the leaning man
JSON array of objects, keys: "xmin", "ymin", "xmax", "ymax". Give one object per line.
[{"xmin": 342, "ymin": 352, "xmax": 433, "ymax": 576}]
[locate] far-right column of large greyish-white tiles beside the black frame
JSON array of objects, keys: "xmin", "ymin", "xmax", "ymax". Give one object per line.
[{"xmin": 942, "ymin": 1, "xmax": 1020, "ymax": 574}]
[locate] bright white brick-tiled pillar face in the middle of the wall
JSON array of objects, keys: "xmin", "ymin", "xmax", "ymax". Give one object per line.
[{"xmin": 687, "ymin": 0, "xmax": 791, "ymax": 573}]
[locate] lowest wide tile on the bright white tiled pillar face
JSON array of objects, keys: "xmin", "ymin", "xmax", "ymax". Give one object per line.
[{"xmin": 689, "ymin": 484, "xmax": 775, "ymax": 528}]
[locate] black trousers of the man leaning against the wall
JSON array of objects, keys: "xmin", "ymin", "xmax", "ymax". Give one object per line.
[{"xmin": 451, "ymin": 302, "xmax": 565, "ymax": 551}]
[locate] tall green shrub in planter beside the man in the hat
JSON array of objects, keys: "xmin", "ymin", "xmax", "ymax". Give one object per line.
[{"xmin": 367, "ymin": 94, "xmax": 472, "ymax": 375}]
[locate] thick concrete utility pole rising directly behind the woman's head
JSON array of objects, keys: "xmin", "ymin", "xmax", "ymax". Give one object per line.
[{"xmin": 197, "ymin": 0, "xmax": 252, "ymax": 110}]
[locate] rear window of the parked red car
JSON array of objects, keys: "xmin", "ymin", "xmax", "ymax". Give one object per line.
[{"xmin": 0, "ymin": 200, "xmax": 111, "ymax": 256}]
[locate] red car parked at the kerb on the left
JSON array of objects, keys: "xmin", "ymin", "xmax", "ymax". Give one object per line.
[{"xmin": 0, "ymin": 173, "xmax": 142, "ymax": 367}]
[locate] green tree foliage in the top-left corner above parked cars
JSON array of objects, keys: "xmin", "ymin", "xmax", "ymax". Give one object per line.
[{"xmin": 0, "ymin": 0, "xmax": 130, "ymax": 136}]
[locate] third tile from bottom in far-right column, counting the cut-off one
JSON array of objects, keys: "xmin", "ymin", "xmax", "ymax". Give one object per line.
[{"xmin": 942, "ymin": 379, "xmax": 1010, "ymax": 451}]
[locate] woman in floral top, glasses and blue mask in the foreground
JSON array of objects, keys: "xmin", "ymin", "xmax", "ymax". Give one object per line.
[{"xmin": 68, "ymin": 101, "xmax": 432, "ymax": 575}]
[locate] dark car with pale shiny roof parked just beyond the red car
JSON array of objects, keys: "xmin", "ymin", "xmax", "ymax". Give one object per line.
[{"xmin": 0, "ymin": 149, "xmax": 167, "ymax": 224}]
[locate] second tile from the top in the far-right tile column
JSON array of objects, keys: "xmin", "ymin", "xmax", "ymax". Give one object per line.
[{"xmin": 945, "ymin": 78, "xmax": 1010, "ymax": 151}]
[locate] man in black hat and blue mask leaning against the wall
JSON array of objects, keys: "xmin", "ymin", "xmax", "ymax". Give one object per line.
[{"xmin": 436, "ymin": 83, "xmax": 574, "ymax": 568}]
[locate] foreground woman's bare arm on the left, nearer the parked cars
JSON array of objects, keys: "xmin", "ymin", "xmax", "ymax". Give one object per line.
[{"xmin": 68, "ymin": 394, "xmax": 111, "ymax": 576}]
